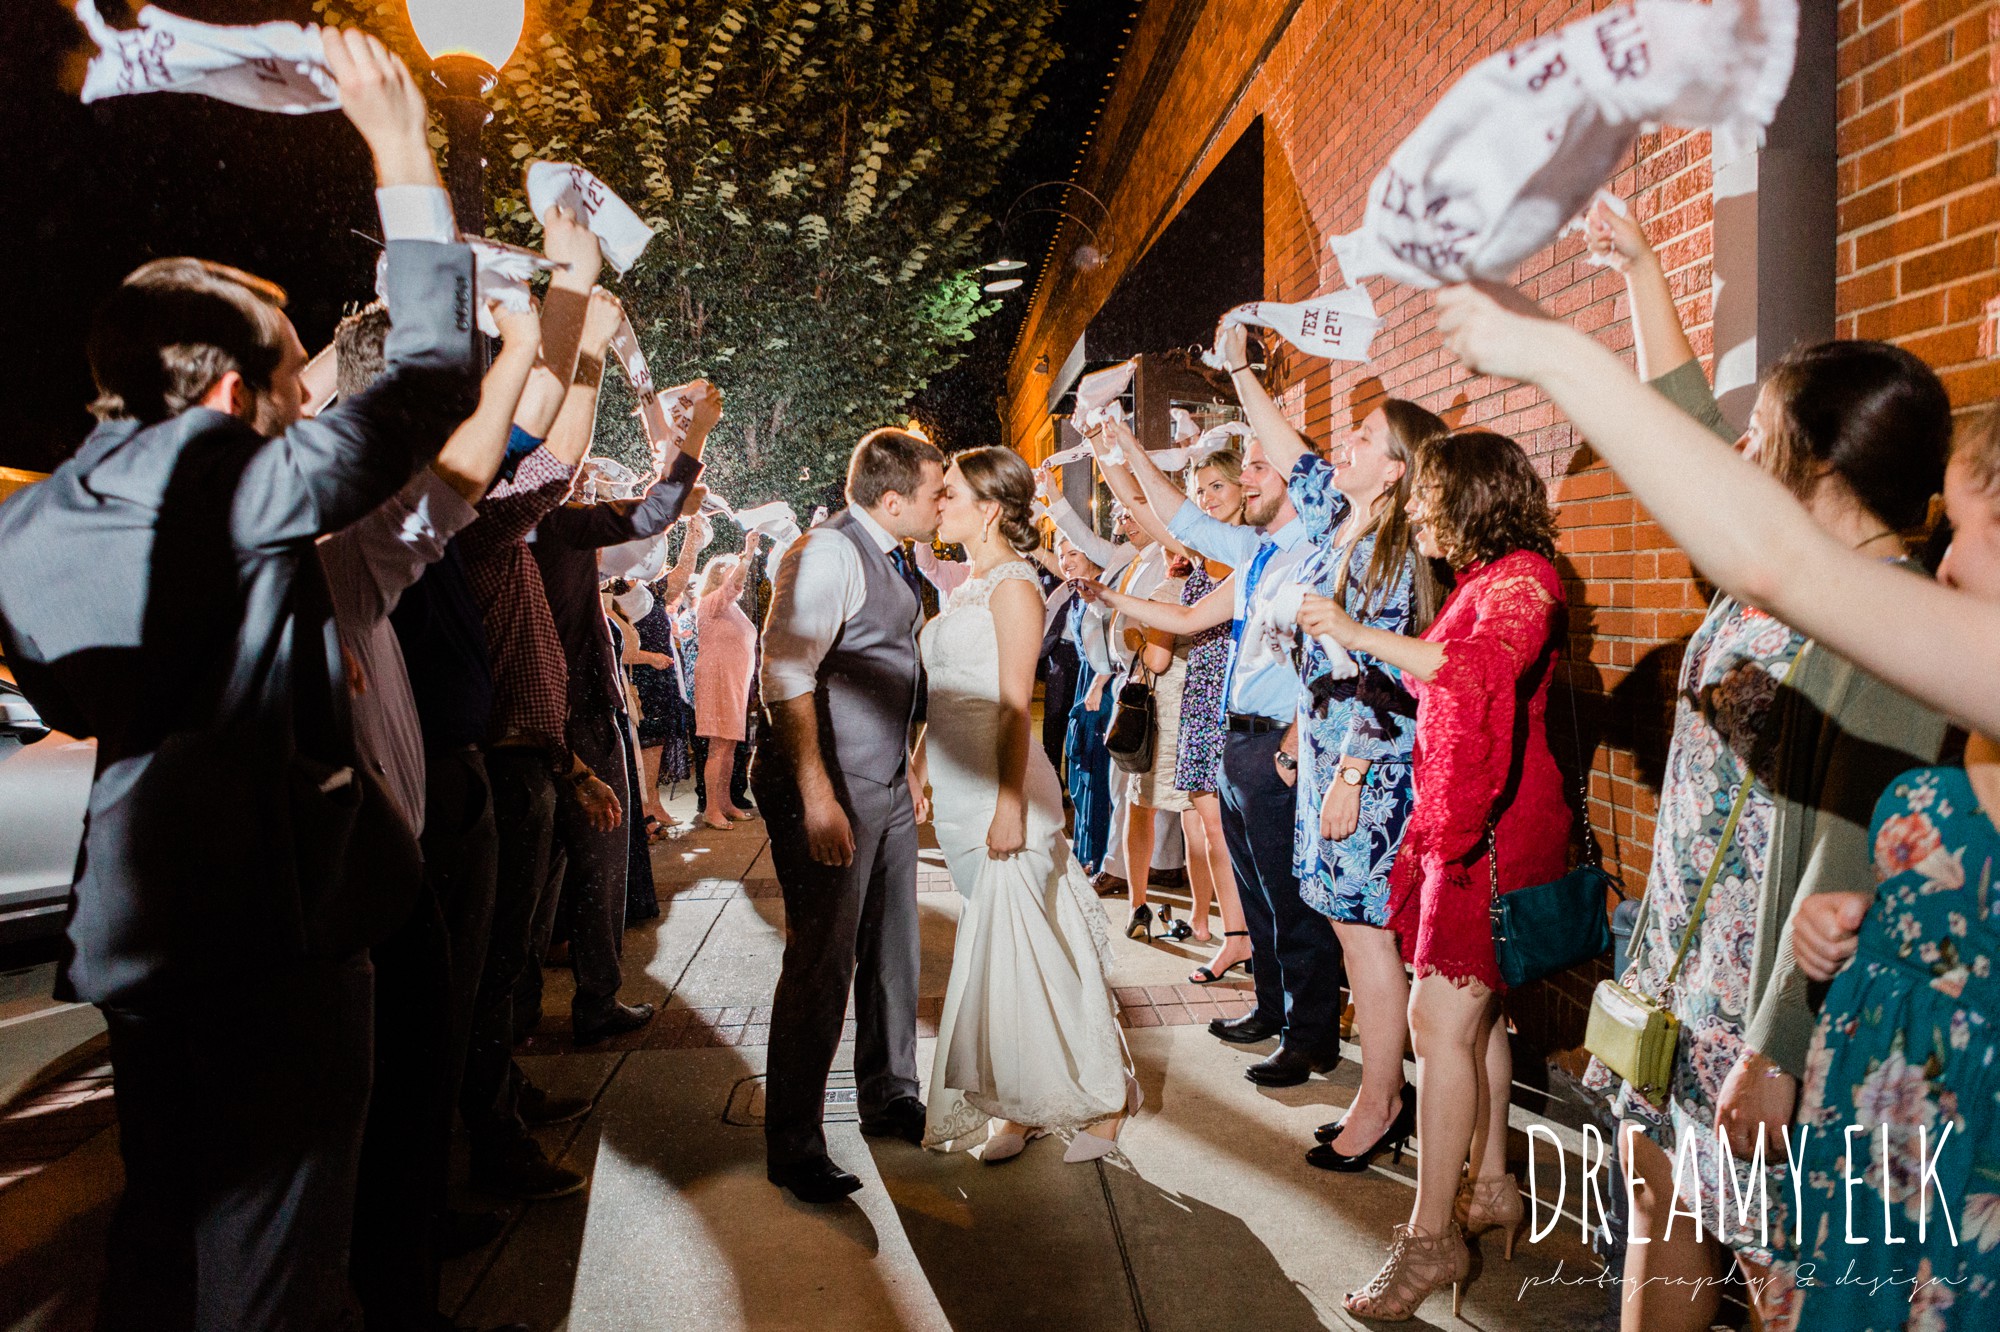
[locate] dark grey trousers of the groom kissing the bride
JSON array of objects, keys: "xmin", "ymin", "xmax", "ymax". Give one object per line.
[{"xmin": 752, "ymin": 768, "xmax": 922, "ymax": 1166}]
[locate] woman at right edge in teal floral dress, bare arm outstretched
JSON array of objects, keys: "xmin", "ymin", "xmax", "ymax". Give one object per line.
[{"xmin": 1438, "ymin": 288, "xmax": 2000, "ymax": 1328}]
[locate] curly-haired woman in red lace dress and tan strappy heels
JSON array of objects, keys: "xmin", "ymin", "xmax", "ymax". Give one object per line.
[{"xmin": 1298, "ymin": 430, "xmax": 1570, "ymax": 1318}]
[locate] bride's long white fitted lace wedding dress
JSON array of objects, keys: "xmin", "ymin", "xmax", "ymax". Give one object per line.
[{"xmin": 922, "ymin": 560, "xmax": 1126, "ymax": 1148}]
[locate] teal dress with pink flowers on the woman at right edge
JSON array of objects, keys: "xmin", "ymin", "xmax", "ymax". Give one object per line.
[{"xmin": 1774, "ymin": 768, "xmax": 2000, "ymax": 1332}]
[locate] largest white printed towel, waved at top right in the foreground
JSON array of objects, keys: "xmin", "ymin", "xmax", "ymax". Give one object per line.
[{"xmin": 1328, "ymin": 0, "xmax": 1798, "ymax": 288}]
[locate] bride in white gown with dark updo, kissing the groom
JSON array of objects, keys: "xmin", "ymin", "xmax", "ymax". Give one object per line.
[{"xmin": 916, "ymin": 448, "xmax": 1138, "ymax": 1164}]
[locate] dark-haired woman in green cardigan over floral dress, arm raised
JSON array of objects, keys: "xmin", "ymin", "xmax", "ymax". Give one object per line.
[{"xmin": 1568, "ymin": 204, "xmax": 1950, "ymax": 1332}]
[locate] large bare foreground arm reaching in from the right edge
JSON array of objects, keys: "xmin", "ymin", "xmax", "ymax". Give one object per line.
[{"xmin": 1438, "ymin": 286, "xmax": 2000, "ymax": 734}]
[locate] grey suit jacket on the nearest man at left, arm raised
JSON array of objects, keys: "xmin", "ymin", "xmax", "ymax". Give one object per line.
[{"xmin": 0, "ymin": 242, "xmax": 480, "ymax": 1006}]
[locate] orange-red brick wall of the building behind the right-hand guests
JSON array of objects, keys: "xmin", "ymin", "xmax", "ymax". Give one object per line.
[{"xmin": 1010, "ymin": 0, "xmax": 2000, "ymax": 1048}]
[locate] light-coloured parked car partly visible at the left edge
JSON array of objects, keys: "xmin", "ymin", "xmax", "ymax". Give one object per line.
[{"xmin": 0, "ymin": 662, "xmax": 98, "ymax": 944}]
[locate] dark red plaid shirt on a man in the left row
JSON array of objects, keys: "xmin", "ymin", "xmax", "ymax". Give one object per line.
[{"xmin": 458, "ymin": 448, "xmax": 576, "ymax": 754}]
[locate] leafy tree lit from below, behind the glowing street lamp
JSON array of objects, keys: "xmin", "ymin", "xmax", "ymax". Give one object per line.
[{"xmin": 316, "ymin": 0, "xmax": 1060, "ymax": 502}]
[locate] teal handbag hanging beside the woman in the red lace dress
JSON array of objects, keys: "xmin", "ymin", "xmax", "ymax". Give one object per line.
[{"xmin": 1486, "ymin": 668, "xmax": 1624, "ymax": 990}]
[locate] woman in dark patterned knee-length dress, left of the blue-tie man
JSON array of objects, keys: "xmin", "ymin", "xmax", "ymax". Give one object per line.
[{"xmin": 1174, "ymin": 448, "xmax": 1250, "ymax": 986}]
